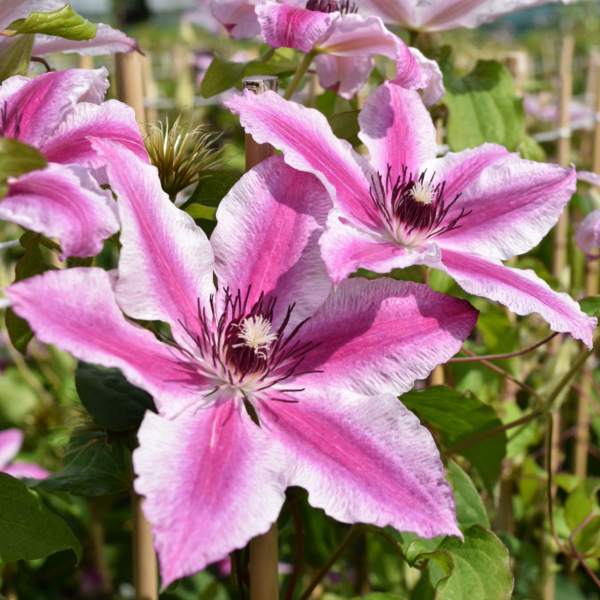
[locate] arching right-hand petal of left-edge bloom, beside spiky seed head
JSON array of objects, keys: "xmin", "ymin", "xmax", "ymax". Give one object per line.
[{"xmin": 40, "ymin": 100, "xmax": 148, "ymax": 173}]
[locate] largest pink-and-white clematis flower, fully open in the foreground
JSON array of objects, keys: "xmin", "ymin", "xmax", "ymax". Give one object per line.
[{"xmin": 6, "ymin": 141, "xmax": 477, "ymax": 585}]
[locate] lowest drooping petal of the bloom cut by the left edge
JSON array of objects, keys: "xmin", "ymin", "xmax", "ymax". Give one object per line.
[{"xmin": 0, "ymin": 163, "xmax": 119, "ymax": 260}]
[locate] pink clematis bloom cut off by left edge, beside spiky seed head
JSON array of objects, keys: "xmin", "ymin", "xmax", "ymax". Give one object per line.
[{"xmin": 0, "ymin": 68, "xmax": 148, "ymax": 256}]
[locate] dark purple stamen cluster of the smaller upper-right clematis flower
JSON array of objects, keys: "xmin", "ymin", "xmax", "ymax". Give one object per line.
[{"xmin": 370, "ymin": 165, "xmax": 472, "ymax": 247}]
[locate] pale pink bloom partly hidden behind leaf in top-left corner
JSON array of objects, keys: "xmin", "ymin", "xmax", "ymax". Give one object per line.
[{"xmin": 0, "ymin": 0, "xmax": 141, "ymax": 56}]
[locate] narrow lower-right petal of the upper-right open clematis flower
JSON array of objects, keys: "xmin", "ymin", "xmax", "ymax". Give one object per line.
[{"xmin": 437, "ymin": 248, "xmax": 598, "ymax": 348}]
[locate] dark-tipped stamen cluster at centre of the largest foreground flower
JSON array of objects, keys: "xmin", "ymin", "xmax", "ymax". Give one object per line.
[{"xmin": 166, "ymin": 287, "xmax": 319, "ymax": 403}]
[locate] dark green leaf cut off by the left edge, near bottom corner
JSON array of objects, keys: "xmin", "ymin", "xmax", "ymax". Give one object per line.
[{"xmin": 0, "ymin": 473, "xmax": 82, "ymax": 563}]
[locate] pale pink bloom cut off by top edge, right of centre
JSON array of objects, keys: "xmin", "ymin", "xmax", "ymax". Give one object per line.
[{"xmin": 361, "ymin": 0, "xmax": 575, "ymax": 31}]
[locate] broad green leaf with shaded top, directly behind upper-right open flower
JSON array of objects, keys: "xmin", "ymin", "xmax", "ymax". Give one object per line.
[{"xmin": 440, "ymin": 60, "xmax": 525, "ymax": 152}]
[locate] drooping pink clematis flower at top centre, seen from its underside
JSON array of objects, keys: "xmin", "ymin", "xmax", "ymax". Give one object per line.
[{"xmin": 211, "ymin": 0, "xmax": 444, "ymax": 104}]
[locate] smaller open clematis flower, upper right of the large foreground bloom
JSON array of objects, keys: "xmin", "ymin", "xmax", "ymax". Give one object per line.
[{"xmin": 224, "ymin": 83, "xmax": 596, "ymax": 345}]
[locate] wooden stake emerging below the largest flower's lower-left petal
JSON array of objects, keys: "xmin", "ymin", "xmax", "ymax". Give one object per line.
[{"xmin": 131, "ymin": 493, "xmax": 158, "ymax": 600}]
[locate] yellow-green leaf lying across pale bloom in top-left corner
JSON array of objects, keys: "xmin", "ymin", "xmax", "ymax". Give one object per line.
[{"xmin": 1, "ymin": 4, "xmax": 98, "ymax": 41}]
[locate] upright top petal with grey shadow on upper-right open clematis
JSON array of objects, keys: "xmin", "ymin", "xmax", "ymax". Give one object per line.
[{"xmin": 358, "ymin": 82, "xmax": 437, "ymax": 180}]
